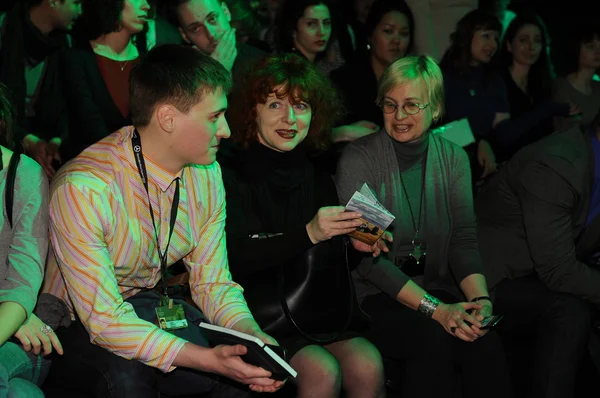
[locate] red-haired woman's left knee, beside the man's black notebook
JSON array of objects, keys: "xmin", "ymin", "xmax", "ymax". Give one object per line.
[{"xmin": 290, "ymin": 345, "xmax": 342, "ymax": 396}]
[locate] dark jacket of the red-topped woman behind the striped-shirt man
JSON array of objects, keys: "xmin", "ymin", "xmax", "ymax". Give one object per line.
[{"xmin": 62, "ymin": 46, "xmax": 131, "ymax": 161}]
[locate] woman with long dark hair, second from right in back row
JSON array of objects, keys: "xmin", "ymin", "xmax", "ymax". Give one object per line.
[{"xmin": 494, "ymin": 14, "xmax": 580, "ymax": 163}]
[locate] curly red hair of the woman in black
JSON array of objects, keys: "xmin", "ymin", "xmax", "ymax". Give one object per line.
[{"xmin": 227, "ymin": 54, "xmax": 341, "ymax": 150}]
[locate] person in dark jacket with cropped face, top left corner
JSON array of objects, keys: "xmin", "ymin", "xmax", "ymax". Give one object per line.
[{"xmin": 0, "ymin": 0, "xmax": 81, "ymax": 178}]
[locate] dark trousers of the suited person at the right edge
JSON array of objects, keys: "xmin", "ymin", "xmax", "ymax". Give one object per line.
[{"xmin": 494, "ymin": 276, "xmax": 592, "ymax": 398}]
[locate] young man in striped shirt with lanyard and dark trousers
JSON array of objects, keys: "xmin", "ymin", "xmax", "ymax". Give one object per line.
[{"xmin": 44, "ymin": 45, "xmax": 281, "ymax": 398}]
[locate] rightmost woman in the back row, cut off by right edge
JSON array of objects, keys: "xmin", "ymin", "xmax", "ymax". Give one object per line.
[{"xmin": 552, "ymin": 23, "xmax": 600, "ymax": 130}]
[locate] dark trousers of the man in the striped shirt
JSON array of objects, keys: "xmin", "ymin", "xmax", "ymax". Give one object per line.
[{"xmin": 49, "ymin": 292, "xmax": 250, "ymax": 398}]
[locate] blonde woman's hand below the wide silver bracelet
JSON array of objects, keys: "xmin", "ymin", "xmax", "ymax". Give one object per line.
[{"xmin": 432, "ymin": 303, "xmax": 483, "ymax": 342}]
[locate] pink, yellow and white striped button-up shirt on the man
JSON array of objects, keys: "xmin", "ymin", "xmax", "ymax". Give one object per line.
[{"xmin": 43, "ymin": 127, "xmax": 252, "ymax": 371}]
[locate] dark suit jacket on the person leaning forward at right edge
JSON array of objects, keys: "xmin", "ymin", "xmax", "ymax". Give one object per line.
[{"xmin": 475, "ymin": 126, "xmax": 600, "ymax": 304}]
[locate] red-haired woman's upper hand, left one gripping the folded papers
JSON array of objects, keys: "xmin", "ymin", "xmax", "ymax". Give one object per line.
[{"xmin": 306, "ymin": 206, "xmax": 361, "ymax": 245}]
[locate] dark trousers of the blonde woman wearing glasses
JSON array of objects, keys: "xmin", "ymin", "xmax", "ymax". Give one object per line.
[{"xmin": 362, "ymin": 291, "xmax": 512, "ymax": 398}]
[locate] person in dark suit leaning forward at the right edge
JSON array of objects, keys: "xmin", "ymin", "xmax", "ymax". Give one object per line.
[{"xmin": 475, "ymin": 107, "xmax": 600, "ymax": 397}]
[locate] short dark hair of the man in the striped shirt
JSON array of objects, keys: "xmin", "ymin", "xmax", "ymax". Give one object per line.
[{"xmin": 129, "ymin": 44, "xmax": 231, "ymax": 127}]
